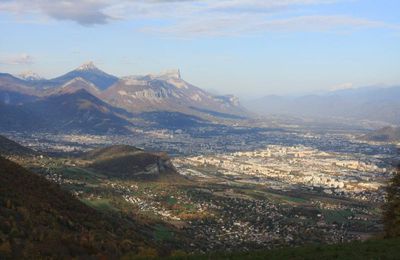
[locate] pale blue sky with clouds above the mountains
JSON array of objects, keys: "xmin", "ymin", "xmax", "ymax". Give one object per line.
[{"xmin": 0, "ymin": 0, "xmax": 400, "ymax": 98}]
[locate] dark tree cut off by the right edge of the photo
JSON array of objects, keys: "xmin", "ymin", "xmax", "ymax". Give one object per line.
[{"xmin": 383, "ymin": 166, "xmax": 400, "ymax": 237}]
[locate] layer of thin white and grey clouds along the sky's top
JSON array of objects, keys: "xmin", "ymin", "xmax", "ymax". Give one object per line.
[{"xmin": 0, "ymin": 0, "xmax": 399, "ymax": 37}]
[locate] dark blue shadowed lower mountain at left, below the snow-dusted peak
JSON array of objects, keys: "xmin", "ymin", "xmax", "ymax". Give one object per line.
[{"xmin": 0, "ymin": 89, "xmax": 131, "ymax": 134}]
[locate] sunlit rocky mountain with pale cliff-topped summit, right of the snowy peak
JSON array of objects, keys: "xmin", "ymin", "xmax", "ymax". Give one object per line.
[{"xmin": 101, "ymin": 70, "xmax": 248, "ymax": 119}]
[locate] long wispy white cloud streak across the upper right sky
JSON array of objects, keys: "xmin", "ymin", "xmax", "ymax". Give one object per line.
[{"xmin": 142, "ymin": 14, "xmax": 399, "ymax": 37}]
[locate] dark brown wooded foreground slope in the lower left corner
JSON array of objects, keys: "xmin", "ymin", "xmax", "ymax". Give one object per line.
[{"xmin": 0, "ymin": 157, "xmax": 155, "ymax": 259}]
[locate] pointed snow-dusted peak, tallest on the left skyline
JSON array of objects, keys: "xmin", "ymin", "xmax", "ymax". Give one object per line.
[{"xmin": 50, "ymin": 62, "xmax": 118, "ymax": 90}]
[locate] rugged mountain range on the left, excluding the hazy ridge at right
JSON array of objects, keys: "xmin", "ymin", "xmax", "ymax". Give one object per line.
[{"xmin": 0, "ymin": 62, "xmax": 249, "ymax": 134}]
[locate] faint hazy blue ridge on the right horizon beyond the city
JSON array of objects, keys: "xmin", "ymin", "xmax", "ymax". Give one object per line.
[{"xmin": 246, "ymin": 86, "xmax": 400, "ymax": 124}]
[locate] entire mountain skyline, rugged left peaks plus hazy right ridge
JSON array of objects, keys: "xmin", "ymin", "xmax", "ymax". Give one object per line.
[{"xmin": 0, "ymin": 62, "xmax": 400, "ymax": 134}]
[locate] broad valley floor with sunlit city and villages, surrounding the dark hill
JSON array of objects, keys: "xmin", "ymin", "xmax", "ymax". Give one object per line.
[{"xmin": 4, "ymin": 126, "xmax": 398, "ymax": 253}]
